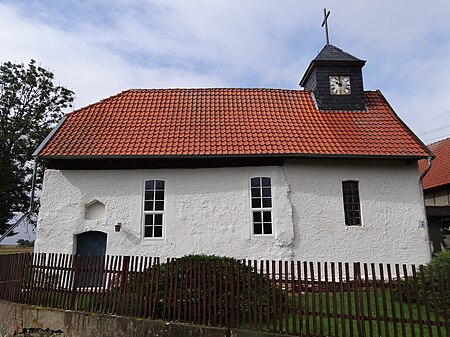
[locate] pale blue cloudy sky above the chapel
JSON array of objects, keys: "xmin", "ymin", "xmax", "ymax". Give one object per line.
[{"xmin": 0, "ymin": 0, "xmax": 450, "ymax": 242}]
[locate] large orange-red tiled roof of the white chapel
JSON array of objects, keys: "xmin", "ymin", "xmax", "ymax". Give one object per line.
[{"xmin": 39, "ymin": 89, "xmax": 428, "ymax": 158}]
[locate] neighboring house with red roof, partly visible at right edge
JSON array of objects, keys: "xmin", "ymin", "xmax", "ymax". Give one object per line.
[{"xmin": 419, "ymin": 138, "xmax": 450, "ymax": 253}]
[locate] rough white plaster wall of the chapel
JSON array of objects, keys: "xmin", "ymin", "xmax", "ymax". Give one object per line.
[{"xmin": 36, "ymin": 160, "xmax": 430, "ymax": 263}]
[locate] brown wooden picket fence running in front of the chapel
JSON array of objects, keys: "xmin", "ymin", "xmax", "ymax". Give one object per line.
[{"xmin": 0, "ymin": 254, "xmax": 450, "ymax": 337}]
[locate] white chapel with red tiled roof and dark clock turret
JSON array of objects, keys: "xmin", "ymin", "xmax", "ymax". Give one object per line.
[{"xmin": 35, "ymin": 45, "xmax": 431, "ymax": 263}]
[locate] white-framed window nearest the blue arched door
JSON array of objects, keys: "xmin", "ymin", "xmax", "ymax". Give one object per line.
[{"xmin": 144, "ymin": 179, "xmax": 165, "ymax": 238}]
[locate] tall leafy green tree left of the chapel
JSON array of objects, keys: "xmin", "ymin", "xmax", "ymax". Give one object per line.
[{"xmin": 0, "ymin": 60, "xmax": 74, "ymax": 234}]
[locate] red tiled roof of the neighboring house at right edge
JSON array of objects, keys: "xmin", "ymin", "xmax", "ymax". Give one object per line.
[{"xmin": 419, "ymin": 138, "xmax": 450, "ymax": 190}]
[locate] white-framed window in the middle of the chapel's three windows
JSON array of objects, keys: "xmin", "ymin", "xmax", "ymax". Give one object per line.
[{"xmin": 250, "ymin": 177, "xmax": 273, "ymax": 236}]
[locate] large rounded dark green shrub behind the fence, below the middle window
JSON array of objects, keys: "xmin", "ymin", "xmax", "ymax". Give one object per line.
[{"xmin": 122, "ymin": 255, "xmax": 284, "ymax": 321}]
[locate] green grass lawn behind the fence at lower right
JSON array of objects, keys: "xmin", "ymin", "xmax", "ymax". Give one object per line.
[{"xmin": 266, "ymin": 291, "xmax": 446, "ymax": 336}]
